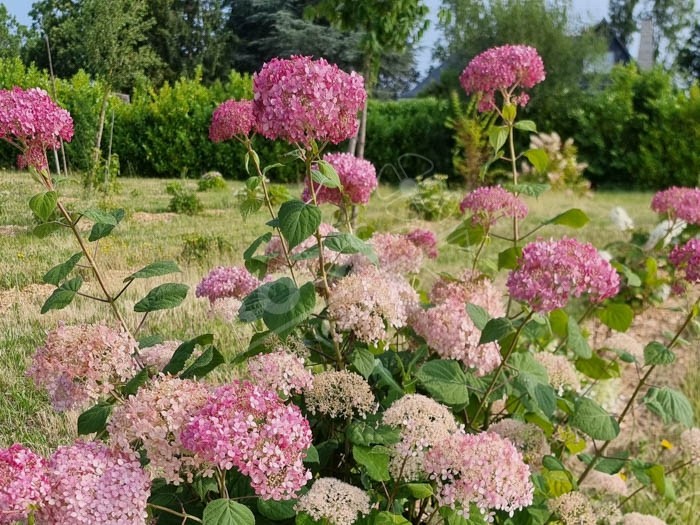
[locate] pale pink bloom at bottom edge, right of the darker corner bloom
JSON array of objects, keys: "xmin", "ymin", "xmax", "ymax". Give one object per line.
[{"xmin": 37, "ymin": 441, "xmax": 151, "ymax": 525}]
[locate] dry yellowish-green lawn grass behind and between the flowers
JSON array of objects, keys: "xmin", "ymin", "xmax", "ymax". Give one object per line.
[{"xmin": 0, "ymin": 172, "xmax": 700, "ymax": 523}]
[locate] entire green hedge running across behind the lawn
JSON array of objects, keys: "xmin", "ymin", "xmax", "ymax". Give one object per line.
[{"xmin": 0, "ymin": 59, "xmax": 700, "ymax": 189}]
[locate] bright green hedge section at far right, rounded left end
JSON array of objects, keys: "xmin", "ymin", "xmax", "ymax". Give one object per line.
[{"xmin": 565, "ymin": 66, "xmax": 700, "ymax": 189}]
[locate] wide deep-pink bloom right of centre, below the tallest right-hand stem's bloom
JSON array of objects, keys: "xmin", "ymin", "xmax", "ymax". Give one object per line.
[{"xmin": 506, "ymin": 237, "xmax": 620, "ymax": 313}]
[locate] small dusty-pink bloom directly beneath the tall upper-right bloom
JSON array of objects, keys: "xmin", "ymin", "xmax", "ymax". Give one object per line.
[{"xmin": 459, "ymin": 186, "xmax": 527, "ymax": 229}]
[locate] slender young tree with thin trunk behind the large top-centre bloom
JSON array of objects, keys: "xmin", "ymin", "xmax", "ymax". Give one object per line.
[{"xmin": 308, "ymin": 0, "xmax": 428, "ymax": 158}]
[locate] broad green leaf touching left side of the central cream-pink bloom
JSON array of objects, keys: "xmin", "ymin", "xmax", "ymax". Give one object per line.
[{"xmin": 258, "ymin": 279, "xmax": 316, "ymax": 338}]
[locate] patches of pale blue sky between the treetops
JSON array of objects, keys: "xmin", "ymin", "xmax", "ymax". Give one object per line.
[{"xmin": 0, "ymin": 0, "xmax": 608, "ymax": 73}]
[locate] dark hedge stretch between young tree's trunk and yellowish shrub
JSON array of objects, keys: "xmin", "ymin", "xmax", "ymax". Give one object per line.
[{"xmin": 365, "ymin": 98, "xmax": 454, "ymax": 184}]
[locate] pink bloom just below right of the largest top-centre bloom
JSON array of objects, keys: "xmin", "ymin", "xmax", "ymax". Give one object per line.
[{"xmin": 301, "ymin": 153, "xmax": 378, "ymax": 206}]
